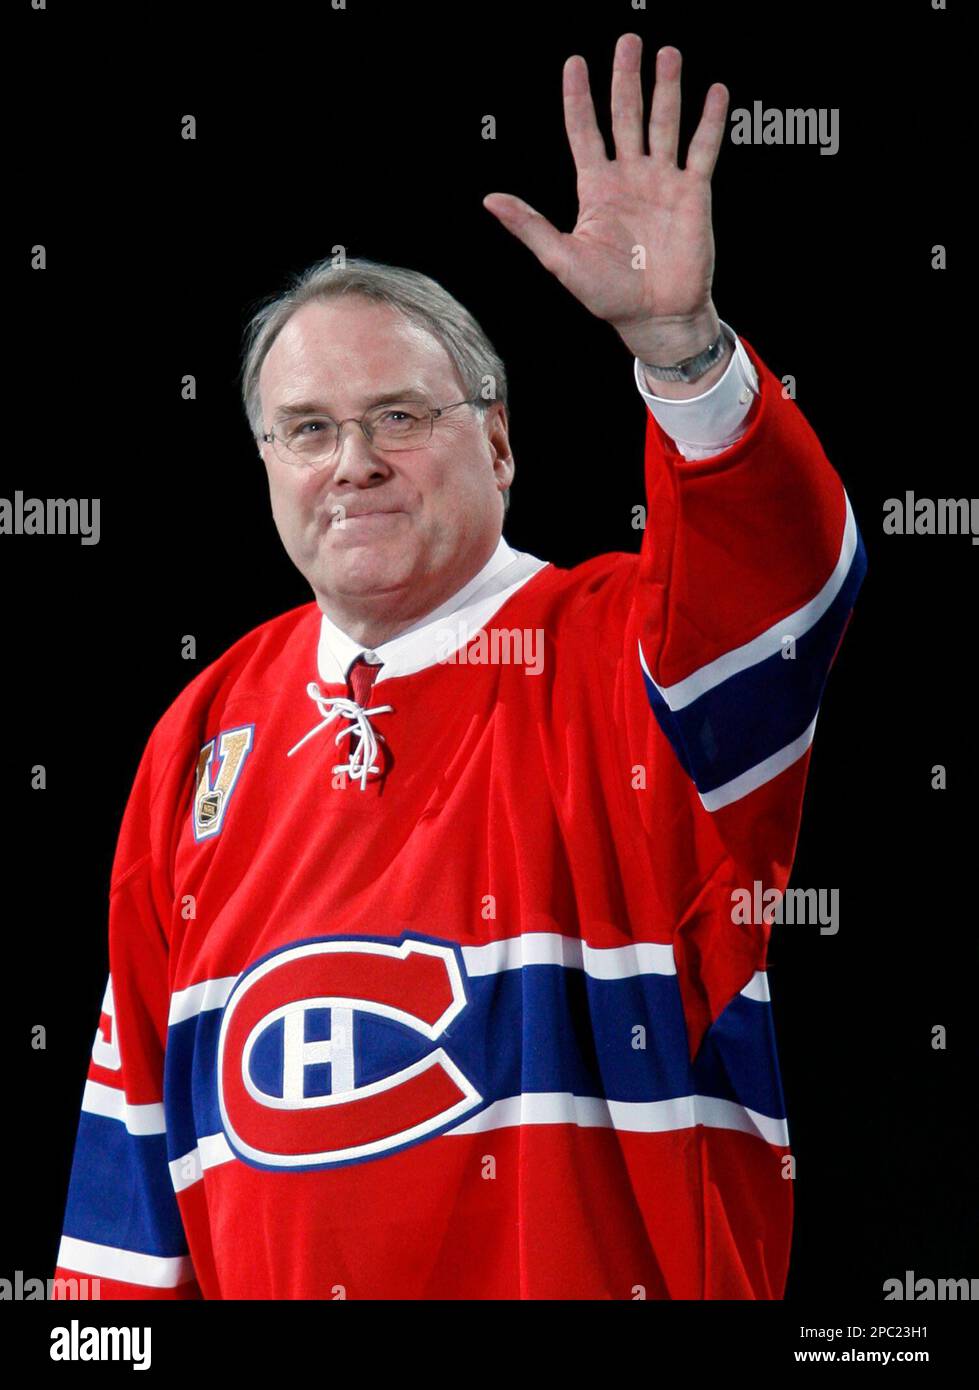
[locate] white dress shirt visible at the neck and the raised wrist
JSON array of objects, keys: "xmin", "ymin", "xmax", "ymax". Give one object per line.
[{"xmin": 317, "ymin": 320, "xmax": 758, "ymax": 682}]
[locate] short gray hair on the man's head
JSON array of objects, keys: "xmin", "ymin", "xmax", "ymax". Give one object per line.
[{"xmin": 242, "ymin": 257, "xmax": 510, "ymax": 512}]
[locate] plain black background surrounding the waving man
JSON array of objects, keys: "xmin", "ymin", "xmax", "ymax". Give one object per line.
[{"xmin": 0, "ymin": 0, "xmax": 979, "ymax": 1345}]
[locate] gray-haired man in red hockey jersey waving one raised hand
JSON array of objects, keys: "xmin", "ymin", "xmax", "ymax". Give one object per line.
[{"xmin": 58, "ymin": 43, "xmax": 865, "ymax": 1300}]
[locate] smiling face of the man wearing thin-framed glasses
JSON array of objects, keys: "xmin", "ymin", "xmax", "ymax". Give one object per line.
[{"xmin": 259, "ymin": 295, "xmax": 513, "ymax": 621}]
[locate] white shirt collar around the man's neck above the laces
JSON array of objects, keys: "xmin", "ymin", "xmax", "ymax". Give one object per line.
[{"xmin": 317, "ymin": 535, "xmax": 548, "ymax": 684}]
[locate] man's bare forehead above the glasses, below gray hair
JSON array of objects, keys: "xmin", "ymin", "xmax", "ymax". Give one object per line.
[{"xmin": 259, "ymin": 296, "xmax": 455, "ymax": 409}]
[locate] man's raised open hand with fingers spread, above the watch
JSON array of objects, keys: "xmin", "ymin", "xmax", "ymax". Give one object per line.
[{"xmin": 483, "ymin": 33, "xmax": 729, "ymax": 360}]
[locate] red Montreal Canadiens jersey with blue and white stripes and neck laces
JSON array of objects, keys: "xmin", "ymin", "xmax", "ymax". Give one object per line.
[{"xmin": 57, "ymin": 343, "xmax": 865, "ymax": 1300}]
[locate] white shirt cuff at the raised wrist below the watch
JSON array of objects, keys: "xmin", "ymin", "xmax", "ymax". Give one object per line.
[{"xmin": 634, "ymin": 318, "xmax": 758, "ymax": 460}]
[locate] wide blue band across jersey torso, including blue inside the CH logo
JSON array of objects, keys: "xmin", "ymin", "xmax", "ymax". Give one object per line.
[{"xmin": 165, "ymin": 965, "xmax": 784, "ymax": 1161}]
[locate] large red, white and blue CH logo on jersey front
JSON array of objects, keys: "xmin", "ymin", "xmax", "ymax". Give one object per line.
[{"xmin": 217, "ymin": 937, "xmax": 483, "ymax": 1169}]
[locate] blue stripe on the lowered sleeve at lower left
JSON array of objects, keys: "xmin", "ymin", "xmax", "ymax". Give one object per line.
[{"xmin": 64, "ymin": 1111, "xmax": 188, "ymax": 1255}]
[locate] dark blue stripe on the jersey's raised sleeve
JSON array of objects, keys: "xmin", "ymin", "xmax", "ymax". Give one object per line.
[{"xmin": 642, "ymin": 532, "xmax": 866, "ymax": 794}]
